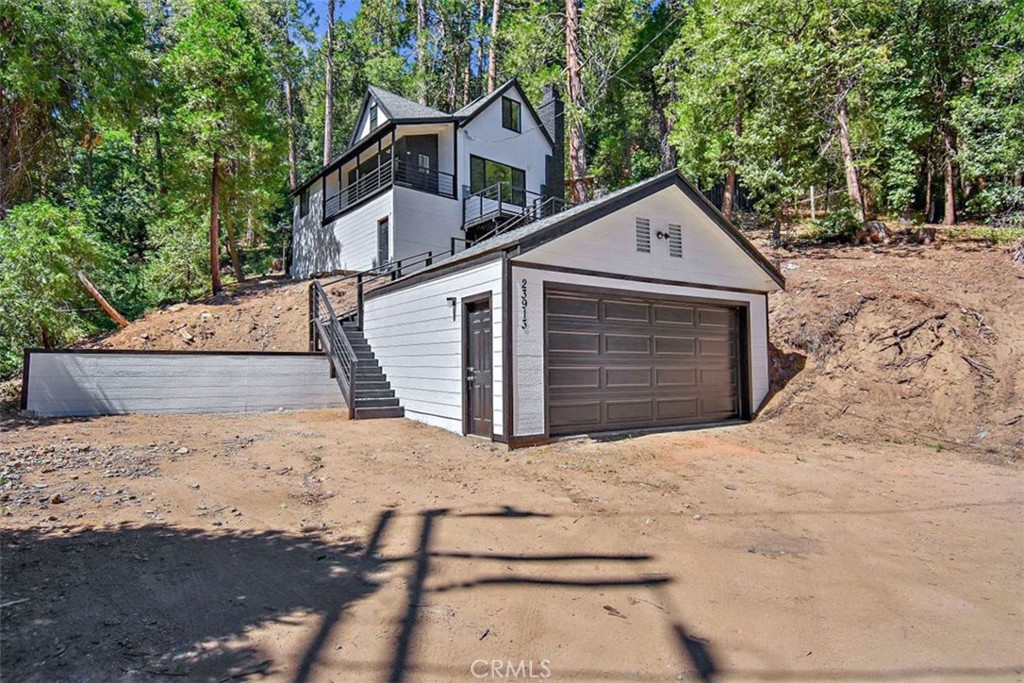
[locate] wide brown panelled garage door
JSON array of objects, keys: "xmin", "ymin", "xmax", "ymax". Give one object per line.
[{"xmin": 545, "ymin": 288, "xmax": 740, "ymax": 435}]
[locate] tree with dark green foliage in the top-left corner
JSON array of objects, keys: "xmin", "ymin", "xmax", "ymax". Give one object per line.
[{"xmin": 0, "ymin": 0, "xmax": 150, "ymax": 211}]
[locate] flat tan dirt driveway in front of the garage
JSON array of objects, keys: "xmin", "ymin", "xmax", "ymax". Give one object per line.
[{"xmin": 0, "ymin": 413, "xmax": 1024, "ymax": 683}]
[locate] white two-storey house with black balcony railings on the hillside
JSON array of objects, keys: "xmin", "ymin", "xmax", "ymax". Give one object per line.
[{"xmin": 290, "ymin": 80, "xmax": 563, "ymax": 278}]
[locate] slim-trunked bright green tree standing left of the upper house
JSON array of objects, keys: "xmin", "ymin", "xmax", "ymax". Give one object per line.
[{"xmin": 166, "ymin": 0, "xmax": 280, "ymax": 293}]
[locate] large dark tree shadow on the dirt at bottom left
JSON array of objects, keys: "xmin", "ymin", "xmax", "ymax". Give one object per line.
[{"xmin": 0, "ymin": 515, "xmax": 387, "ymax": 681}]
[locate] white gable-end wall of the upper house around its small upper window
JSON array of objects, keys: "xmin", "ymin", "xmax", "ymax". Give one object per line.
[{"xmin": 459, "ymin": 88, "xmax": 551, "ymax": 197}]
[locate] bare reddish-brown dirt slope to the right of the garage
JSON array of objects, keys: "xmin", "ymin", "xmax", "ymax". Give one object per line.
[{"xmin": 762, "ymin": 243, "xmax": 1024, "ymax": 458}]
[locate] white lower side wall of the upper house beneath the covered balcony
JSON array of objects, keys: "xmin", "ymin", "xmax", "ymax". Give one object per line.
[{"xmin": 292, "ymin": 189, "xmax": 394, "ymax": 278}]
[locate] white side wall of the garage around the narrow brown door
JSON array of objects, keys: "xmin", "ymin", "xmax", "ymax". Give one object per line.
[{"xmin": 364, "ymin": 259, "xmax": 504, "ymax": 434}]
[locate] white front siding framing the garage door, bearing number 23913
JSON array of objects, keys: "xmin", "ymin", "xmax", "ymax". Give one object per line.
[{"xmin": 510, "ymin": 264, "xmax": 768, "ymax": 436}]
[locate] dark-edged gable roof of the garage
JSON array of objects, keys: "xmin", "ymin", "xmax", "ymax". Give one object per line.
[{"xmin": 366, "ymin": 170, "xmax": 785, "ymax": 294}]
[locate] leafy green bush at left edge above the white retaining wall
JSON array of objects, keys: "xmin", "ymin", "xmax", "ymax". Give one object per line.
[{"xmin": 0, "ymin": 200, "xmax": 108, "ymax": 378}]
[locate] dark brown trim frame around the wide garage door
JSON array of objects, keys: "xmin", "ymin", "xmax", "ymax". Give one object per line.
[{"xmin": 542, "ymin": 280, "xmax": 752, "ymax": 439}]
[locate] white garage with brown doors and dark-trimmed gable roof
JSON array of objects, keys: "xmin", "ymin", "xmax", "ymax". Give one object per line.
[{"xmin": 364, "ymin": 171, "xmax": 784, "ymax": 445}]
